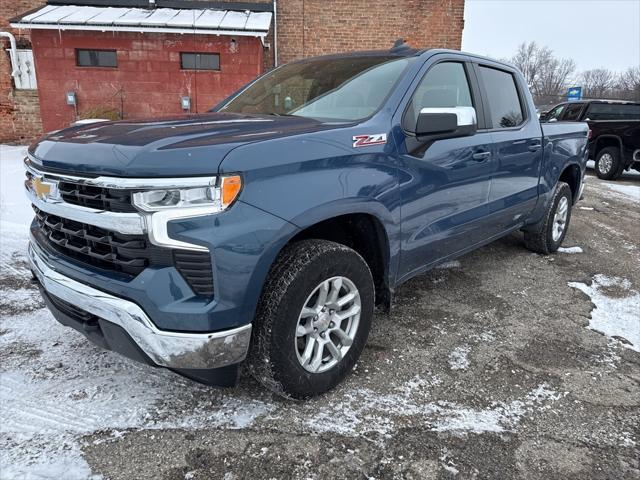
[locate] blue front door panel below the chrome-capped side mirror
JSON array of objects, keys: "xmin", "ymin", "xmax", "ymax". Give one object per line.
[{"xmin": 399, "ymin": 133, "xmax": 493, "ymax": 277}]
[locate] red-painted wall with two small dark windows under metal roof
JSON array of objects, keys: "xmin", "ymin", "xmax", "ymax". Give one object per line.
[{"xmin": 31, "ymin": 30, "xmax": 263, "ymax": 131}]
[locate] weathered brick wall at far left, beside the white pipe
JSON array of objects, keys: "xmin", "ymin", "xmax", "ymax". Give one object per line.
[{"xmin": 0, "ymin": 0, "xmax": 45, "ymax": 143}]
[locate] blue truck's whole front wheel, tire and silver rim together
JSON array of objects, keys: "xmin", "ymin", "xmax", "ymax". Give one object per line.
[{"xmin": 249, "ymin": 240, "xmax": 374, "ymax": 398}]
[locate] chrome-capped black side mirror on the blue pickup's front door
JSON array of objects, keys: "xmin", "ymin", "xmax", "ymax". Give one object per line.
[{"xmin": 416, "ymin": 107, "xmax": 478, "ymax": 138}]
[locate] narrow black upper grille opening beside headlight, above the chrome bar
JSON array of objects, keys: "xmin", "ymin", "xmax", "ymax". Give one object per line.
[{"xmin": 58, "ymin": 181, "xmax": 136, "ymax": 212}]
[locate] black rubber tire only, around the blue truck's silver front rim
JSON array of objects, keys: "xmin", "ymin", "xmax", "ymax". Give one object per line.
[{"xmin": 248, "ymin": 240, "xmax": 375, "ymax": 399}]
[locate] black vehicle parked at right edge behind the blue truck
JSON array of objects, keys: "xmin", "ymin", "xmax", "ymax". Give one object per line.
[{"xmin": 540, "ymin": 100, "xmax": 640, "ymax": 180}]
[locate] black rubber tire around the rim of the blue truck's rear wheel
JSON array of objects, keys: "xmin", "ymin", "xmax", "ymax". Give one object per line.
[{"xmin": 524, "ymin": 182, "xmax": 573, "ymax": 255}]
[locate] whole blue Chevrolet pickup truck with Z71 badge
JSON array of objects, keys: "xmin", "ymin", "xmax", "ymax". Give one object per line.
[{"xmin": 25, "ymin": 45, "xmax": 587, "ymax": 398}]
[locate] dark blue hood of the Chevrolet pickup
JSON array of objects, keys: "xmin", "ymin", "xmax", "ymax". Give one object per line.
[{"xmin": 29, "ymin": 113, "xmax": 336, "ymax": 177}]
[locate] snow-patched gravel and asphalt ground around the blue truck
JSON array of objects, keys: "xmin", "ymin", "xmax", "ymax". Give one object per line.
[{"xmin": 0, "ymin": 147, "xmax": 640, "ymax": 480}]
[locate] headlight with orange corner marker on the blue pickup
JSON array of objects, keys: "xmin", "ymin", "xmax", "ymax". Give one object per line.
[{"xmin": 133, "ymin": 175, "xmax": 242, "ymax": 214}]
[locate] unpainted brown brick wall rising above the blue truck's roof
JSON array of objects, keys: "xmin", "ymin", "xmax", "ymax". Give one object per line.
[{"xmin": 278, "ymin": 0, "xmax": 464, "ymax": 63}]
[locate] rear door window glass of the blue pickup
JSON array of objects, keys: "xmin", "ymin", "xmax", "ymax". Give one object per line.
[{"xmin": 479, "ymin": 65, "xmax": 525, "ymax": 128}]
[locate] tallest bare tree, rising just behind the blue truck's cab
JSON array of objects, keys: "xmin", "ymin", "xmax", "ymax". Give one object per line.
[{"xmin": 511, "ymin": 42, "xmax": 576, "ymax": 105}]
